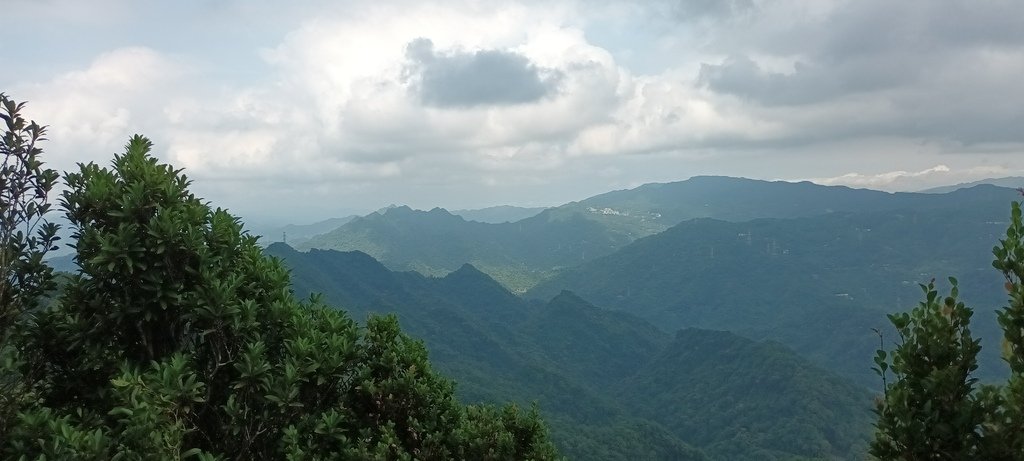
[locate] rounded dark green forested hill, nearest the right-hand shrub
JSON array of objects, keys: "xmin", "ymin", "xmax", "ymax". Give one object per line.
[{"xmin": 617, "ymin": 329, "xmax": 870, "ymax": 460}]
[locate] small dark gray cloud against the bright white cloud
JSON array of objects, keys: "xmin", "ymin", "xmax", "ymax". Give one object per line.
[{"xmin": 406, "ymin": 38, "xmax": 561, "ymax": 108}]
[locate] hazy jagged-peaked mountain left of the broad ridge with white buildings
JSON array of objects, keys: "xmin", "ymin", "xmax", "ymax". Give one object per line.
[{"xmin": 297, "ymin": 206, "xmax": 629, "ymax": 290}]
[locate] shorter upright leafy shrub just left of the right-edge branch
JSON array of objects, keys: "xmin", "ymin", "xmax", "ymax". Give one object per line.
[{"xmin": 871, "ymin": 278, "xmax": 984, "ymax": 460}]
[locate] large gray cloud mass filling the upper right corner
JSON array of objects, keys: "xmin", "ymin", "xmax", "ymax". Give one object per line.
[{"xmin": 694, "ymin": 0, "xmax": 1024, "ymax": 150}]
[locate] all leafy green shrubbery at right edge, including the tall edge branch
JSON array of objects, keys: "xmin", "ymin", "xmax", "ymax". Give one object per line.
[{"xmin": 870, "ymin": 196, "xmax": 1024, "ymax": 461}]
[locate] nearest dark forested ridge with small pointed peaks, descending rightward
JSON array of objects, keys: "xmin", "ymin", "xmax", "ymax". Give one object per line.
[{"xmin": 267, "ymin": 245, "xmax": 870, "ymax": 459}]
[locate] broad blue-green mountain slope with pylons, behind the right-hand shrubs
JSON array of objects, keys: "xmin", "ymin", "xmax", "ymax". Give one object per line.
[{"xmin": 528, "ymin": 186, "xmax": 1015, "ymax": 384}]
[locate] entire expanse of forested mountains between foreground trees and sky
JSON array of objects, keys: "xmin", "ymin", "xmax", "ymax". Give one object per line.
[{"xmin": 267, "ymin": 177, "xmax": 1017, "ymax": 459}]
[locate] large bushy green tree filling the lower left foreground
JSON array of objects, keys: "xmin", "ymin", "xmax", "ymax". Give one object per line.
[{"xmin": 0, "ymin": 136, "xmax": 555, "ymax": 459}]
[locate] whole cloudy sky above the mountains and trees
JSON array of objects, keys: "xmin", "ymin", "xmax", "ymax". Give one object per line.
[{"xmin": 0, "ymin": 0, "xmax": 1024, "ymax": 223}]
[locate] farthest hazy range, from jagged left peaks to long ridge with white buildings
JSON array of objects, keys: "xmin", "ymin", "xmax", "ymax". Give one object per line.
[{"xmin": 296, "ymin": 176, "xmax": 1015, "ymax": 292}]
